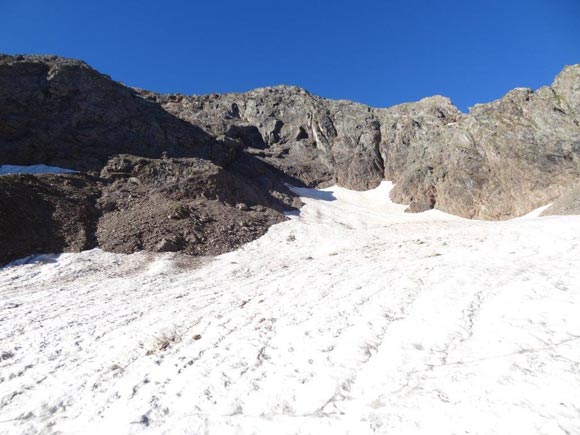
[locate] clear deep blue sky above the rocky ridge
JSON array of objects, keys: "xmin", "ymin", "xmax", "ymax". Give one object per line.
[{"xmin": 0, "ymin": 0, "xmax": 580, "ymax": 110}]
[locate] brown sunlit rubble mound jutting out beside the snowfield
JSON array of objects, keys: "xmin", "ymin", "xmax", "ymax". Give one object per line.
[{"xmin": 96, "ymin": 155, "xmax": 292, "ymax": 255}]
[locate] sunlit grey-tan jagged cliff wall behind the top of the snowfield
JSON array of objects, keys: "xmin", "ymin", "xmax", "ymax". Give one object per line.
[{"xmin": 151, "ymin": 69, "xmax": 580, "ymax": 219}]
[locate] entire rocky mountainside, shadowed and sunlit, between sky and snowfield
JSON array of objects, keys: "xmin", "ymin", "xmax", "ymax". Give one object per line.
[{"xmin": 0, "ymin": 55, "xmax": 580, "ymax": 263}]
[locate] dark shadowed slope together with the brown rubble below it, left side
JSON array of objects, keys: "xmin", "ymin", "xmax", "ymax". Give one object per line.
[{"xmin": 0, "ymin": 56, "xmax": 299, "ymax": 264}]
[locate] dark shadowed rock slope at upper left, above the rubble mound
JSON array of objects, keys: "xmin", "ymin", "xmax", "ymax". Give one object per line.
[{"xmin": 0, "ymin": 56, "xmax": 236, "ymax": 171}]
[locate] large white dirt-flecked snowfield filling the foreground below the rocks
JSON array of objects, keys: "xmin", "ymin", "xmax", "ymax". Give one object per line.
[{"xmin": 0, "ymin": 183, "xmax": 580, "ymax": 435}]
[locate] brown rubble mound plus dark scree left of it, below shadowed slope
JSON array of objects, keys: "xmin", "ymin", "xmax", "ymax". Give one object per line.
[{"xmin": 0, "ymin": 155, "xmax": 299, "ymax": 264}]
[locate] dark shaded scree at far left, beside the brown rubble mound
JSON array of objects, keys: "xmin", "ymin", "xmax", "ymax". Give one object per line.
[{"xmin": 0, "ymin": 174, "xmax": 99, "ymax": 265}]
